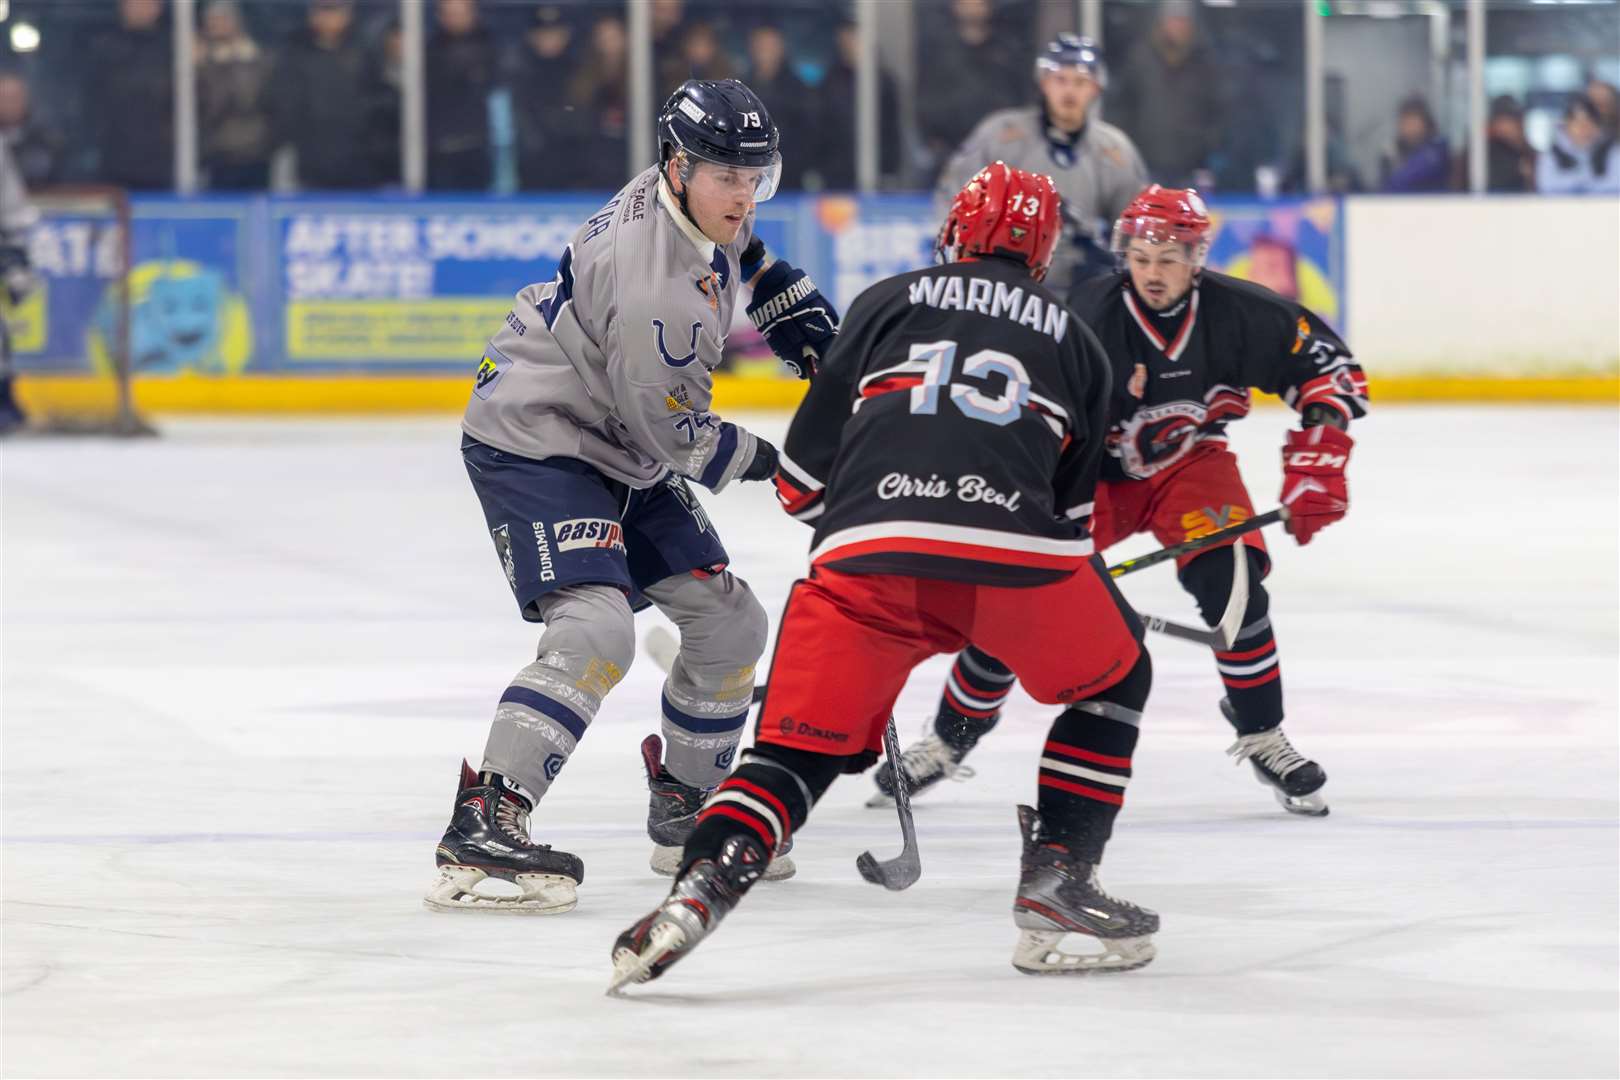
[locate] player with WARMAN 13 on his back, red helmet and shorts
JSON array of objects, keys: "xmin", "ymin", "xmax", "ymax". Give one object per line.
[{"xmin": 614, "ymin": 162, "xmax": 1158, "ymax": 988}]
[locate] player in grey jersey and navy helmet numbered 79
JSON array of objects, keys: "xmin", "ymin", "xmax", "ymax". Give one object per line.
[{"xmin": 426, "ymin": 79, "xmax": 838, "ymax": 913}]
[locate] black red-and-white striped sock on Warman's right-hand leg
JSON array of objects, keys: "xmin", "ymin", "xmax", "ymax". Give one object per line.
[{"xmin": 1038, "ymin": 651, "xmax": 1153, "ymax": 863}]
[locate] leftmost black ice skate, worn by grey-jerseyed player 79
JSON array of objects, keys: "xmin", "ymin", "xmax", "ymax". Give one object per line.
[{"xmin": 423, "ymin": 761, "xmax": 585, "ymax": 915}]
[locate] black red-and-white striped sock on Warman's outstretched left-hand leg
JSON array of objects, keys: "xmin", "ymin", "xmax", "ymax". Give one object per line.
[{"xmin": 680, "ymin": 745, "xmax": 844, "ymax": 871}]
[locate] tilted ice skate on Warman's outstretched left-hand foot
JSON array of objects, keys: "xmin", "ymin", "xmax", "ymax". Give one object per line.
[{"xmin": 608, "ymin": 834, "xmax": 766, "ymax": 994}]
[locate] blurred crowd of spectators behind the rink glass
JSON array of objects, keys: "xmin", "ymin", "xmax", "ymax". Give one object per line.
[{"xmin": 0, "ymin": 0, "xmax": 1620, "ymax": 194}]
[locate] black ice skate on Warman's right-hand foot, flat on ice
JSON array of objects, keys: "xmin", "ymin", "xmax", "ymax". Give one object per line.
[{"xmin": 1013, "ymin": 806, "xmax": 1158, "ymax": 975}]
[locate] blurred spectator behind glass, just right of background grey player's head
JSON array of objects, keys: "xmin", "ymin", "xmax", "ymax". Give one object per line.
[{"xmin": 1108, "ymin": 0, "xmax": 1225, "ymax": 188}]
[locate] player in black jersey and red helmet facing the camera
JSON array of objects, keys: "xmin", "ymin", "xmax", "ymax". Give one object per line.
[{"xmin": 872, "ymin": 185, "xmax": 1367, "ymax": 816}]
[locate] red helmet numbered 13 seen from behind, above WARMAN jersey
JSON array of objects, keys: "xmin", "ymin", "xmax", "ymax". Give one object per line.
[{"xmin": 935, "ymin": 162, "xmax": 1063, "ymax": 282}]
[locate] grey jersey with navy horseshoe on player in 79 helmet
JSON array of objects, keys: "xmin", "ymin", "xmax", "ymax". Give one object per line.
[{"xmin": 462, "ymin": 167, "xmax": 755, "ymax": 491}]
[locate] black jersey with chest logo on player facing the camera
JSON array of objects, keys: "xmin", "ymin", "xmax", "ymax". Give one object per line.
[{"xmin": 1069, "ymin": 270, "xmax": 1367, "ymax": 479}]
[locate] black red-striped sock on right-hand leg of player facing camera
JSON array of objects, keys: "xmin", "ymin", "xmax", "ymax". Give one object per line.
[{"xmin": 1181, "ymin": 547, "xmax": 1283, "ymax": 735}]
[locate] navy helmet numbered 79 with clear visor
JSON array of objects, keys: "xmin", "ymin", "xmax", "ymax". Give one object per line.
[{"xmin": 658, "ymin": 79, "xmax": 782, "ymax": 202}]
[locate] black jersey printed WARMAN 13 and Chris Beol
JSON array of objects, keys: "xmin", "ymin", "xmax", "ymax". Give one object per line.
[{"xmin": 776, "ymin": 257, "xmax": 1110, "ymax": 586}]
